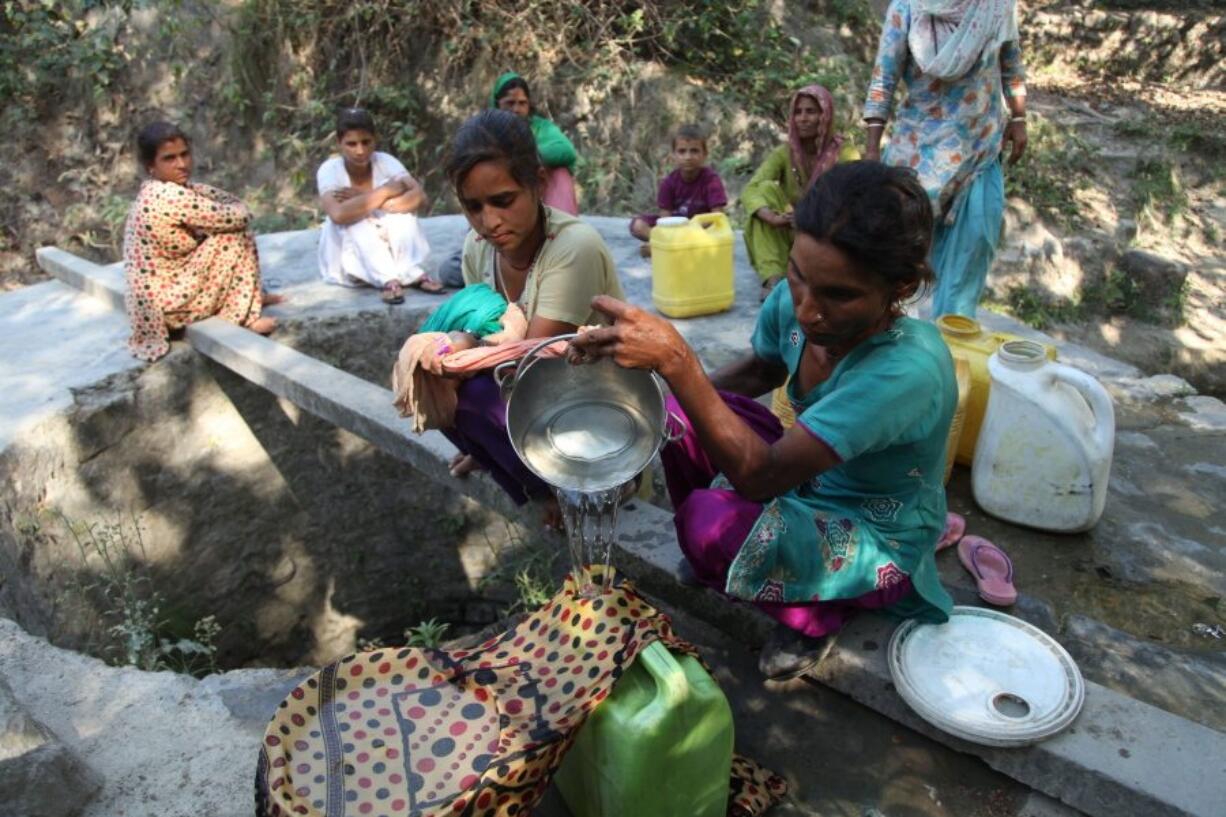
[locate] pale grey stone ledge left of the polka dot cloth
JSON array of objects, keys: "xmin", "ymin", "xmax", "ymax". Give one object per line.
[{"xmin": 0, "ymin": 618, "xmax": 305, "ymax": 817}]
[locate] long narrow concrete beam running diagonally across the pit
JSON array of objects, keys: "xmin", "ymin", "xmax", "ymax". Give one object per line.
[{"xmin": 39, "ymin": 250, "xmax": 1226, "ymax": 817}]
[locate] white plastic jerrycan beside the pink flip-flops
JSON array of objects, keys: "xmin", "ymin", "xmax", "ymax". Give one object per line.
[{"xmin": 971, "ymin": 340, "xmax": 1116, "ymax": 532}]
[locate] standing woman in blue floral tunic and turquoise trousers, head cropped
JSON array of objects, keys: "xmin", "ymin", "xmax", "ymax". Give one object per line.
[{"xmin": 864, "ymin": 0, "xmax": 1026, "ymax": 318}]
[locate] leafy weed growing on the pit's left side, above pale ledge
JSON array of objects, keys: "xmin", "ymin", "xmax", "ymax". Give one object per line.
[{"xmin": 54, "ymin": 512, "xmax": 222, "ymax": 676}]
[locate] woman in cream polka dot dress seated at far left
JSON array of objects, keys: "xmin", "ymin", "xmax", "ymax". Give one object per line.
[{"xmin": 124, "ymin": 121, "xmax": 281, "ymax": 361}]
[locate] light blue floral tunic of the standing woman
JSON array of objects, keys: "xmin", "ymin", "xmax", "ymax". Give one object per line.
[{"xmin": 864, "ymin": 0, "xmax": 1026, "ymax": 222}]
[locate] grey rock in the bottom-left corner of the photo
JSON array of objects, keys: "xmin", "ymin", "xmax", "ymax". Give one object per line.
[{"xmin": 0, "ymin": 677, "xmax": 102, "ymax": 817}]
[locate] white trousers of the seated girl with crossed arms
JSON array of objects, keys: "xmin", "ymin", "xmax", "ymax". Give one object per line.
[{"xmin": 319, "ymin": 210, "xmax": 430, "ymax": 288}]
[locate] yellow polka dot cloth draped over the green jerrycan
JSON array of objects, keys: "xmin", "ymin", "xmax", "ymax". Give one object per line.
[{"xmin": 256, "ymin": 566, "xmax": 786, "ymax": 817}]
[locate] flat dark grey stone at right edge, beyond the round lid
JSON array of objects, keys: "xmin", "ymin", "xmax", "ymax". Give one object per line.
[{"xmin": 1060, "ymin": 615, "xmax": 1226, "ymax": 731}]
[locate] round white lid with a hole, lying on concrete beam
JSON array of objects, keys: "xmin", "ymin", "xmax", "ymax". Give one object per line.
[{"xmin": 889, "ymin": 607, "xmax": 1085, "ymax": 746}]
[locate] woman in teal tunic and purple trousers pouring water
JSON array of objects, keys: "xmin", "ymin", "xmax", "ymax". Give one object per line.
[{"xmin": 573, "ymin": 162, "xmax": 956, "ymax": 678}]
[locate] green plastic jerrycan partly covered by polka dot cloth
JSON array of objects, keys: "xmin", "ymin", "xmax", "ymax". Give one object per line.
[{"xmin": 554, "ymin": 642, "xmax": 732, "ymax": 817}]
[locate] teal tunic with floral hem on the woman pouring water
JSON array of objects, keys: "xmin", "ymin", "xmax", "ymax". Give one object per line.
[{"xmin": 712, "ymin": 287, "xmax": 958, "ymax": 621}]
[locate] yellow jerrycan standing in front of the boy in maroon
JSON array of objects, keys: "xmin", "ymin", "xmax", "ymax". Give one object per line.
[{"xmin": 651, "ymin": 212, "xmax": 733, "ymax": 318}]
